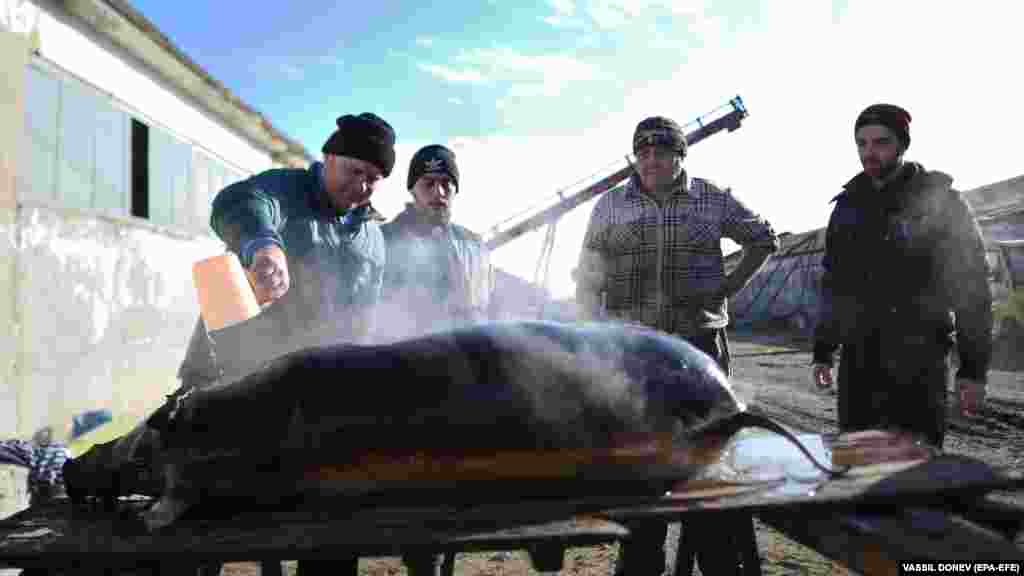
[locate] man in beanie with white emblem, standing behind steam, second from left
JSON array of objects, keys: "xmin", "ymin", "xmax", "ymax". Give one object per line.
[{"xmin": 375, "ymin": 145, "xmax": 493, "ymax": 341}]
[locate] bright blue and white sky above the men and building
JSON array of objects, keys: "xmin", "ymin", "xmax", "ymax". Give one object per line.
[{"xmin": 132, "ymin": 0, "xmax": 1024, "ymax": 298}]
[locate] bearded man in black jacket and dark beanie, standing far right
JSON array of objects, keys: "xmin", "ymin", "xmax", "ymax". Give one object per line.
[{"xmin": 813, "ymin": 105, "xmax": 992, "ymax": 448}]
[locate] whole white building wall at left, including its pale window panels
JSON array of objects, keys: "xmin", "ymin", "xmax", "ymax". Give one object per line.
[{"xmin": 0, "ymin": 0, "xmax": 288, "ymax": 438}]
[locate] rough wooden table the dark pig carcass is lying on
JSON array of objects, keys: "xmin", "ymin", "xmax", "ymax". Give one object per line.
[{"xmin": 0, "ymin": 428, "xmax": 1024, "ymax": 574}]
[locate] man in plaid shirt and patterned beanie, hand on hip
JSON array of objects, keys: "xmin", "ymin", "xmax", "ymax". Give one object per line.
[{"xmin": 577, "ymin": 117, "xmax": 778, "ymax": 574}]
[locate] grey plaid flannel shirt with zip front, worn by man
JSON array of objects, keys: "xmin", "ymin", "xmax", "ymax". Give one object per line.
[{"xmin": 577, "ymin": 171, "xmax": 778, "ymax": 336}]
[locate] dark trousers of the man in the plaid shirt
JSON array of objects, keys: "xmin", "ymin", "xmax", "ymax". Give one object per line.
[{"xmin": 620, "ymin": 329, "xmax": 761, "ymax": 576}]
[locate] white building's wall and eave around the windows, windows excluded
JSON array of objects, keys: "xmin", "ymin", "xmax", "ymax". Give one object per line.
[{"xmin": 0, "ymin": 0, "xmax": 272, "ymax": 438}]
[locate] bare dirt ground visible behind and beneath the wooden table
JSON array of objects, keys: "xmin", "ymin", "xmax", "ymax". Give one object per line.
[{"xmin": 211, "ymin": 332, "xmax": 1024, "ymax": 576}]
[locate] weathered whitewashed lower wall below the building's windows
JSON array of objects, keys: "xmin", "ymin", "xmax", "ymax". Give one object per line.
[{"xmin": 11, "ymin": 206, "xmax": 223, "ymax": 437}]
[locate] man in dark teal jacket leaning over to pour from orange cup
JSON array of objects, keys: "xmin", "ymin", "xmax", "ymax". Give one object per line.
[{"xmin": 178, "ymin": 113, "xmax": 394, "ymax": 386}]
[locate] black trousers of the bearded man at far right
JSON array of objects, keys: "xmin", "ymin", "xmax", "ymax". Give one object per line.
[{"xmin": 838, "ymin": 327, "xmax": 952, "ymax": 448}]
